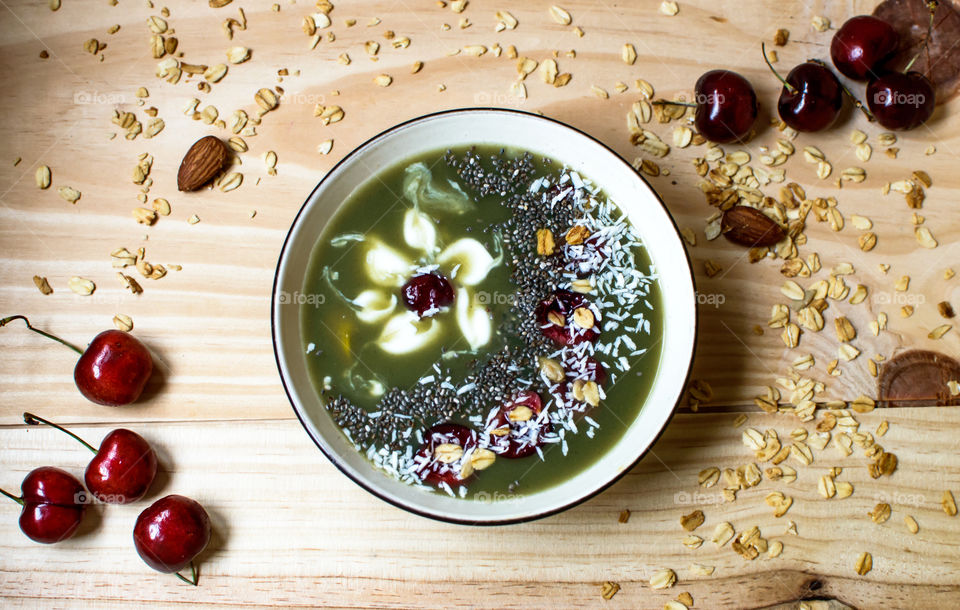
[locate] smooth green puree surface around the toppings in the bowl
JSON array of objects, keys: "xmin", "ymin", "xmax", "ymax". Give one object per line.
[{"xmin": 298, "ymin": 146, "xmax": 663, "ymax": 500}]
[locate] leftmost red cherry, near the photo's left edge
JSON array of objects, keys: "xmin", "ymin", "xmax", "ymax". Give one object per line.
[{"xmin": 0, "ymin": 466, "xmax": 87, "ymax": 544}]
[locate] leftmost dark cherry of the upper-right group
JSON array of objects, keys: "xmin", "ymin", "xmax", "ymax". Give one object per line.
[{"xmin": 694, "ymin": 70, "xmax": 758, "ymax": 144}]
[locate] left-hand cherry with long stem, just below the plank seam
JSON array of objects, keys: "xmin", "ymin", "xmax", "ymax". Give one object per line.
[{"xmin": 23, "ymin": 413, "xmax": 157, "ymax": 504}]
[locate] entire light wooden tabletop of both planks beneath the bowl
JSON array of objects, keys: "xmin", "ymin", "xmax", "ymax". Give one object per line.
[{"xmin": 0, "ymin": 0, "xmax": 960, "ymax": 608}]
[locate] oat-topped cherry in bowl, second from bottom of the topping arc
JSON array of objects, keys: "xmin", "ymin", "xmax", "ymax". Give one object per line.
[{"xmin": 486, "ymin": 390, "xmax": 553, "ymax": 459}]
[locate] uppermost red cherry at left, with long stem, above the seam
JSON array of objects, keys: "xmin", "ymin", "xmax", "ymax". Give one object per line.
[{"xmin": 0, "ymin": 315, "xmax": 153, "ymax": 407}]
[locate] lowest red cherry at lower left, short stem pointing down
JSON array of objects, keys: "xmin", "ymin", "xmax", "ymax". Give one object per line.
[{"xmin": 133, "ymin": 495, "xmax": 210, "ymax": 584}]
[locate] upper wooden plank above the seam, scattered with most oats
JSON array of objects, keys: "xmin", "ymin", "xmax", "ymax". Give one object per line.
[{"xmin": 0, "ymin": 0, "xmax": 960, "ymax": 423}]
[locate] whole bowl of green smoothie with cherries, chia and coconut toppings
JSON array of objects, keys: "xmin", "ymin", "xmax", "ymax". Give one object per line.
[{"xmin": 272, "ymin": 109, "xmax": 696, "ymax": 525}]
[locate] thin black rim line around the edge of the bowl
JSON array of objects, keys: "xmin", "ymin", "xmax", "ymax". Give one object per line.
[{"xmin": 270, "ymin": 107, "xmax": 699, "ymax": 525}]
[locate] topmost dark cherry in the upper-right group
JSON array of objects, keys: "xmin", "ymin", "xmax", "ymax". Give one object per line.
[{"xmin": 830, "ymin": 15, "xmax": 900, "ymax": 80}]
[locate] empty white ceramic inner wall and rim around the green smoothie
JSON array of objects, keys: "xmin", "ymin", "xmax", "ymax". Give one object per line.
[{"xmin": 272, "ymin": 108, "xmax": 697, "ymax": 524}]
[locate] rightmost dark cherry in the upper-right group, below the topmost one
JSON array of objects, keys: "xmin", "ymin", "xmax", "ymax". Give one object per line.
[{"xmin": 867, "ymin": 72, "xmax": 936, "ymax": 129}]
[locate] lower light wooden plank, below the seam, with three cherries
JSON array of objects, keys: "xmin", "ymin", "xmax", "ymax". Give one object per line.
[{"xmin": 0, "ymin": 408, "xmax": 960, "ymax": 608}]
